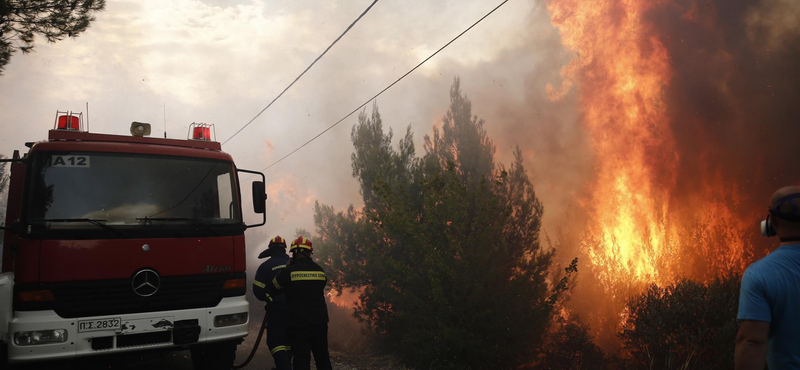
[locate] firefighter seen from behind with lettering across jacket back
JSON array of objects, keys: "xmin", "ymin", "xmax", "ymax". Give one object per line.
[{"xmin": 271, "ymin": 236, "xmax": 332, "ymax": 370}]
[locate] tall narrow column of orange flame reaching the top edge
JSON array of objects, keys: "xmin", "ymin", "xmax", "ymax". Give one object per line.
[{"xmin": 548, "ymin": 0, "xmax": 678, "ymax": 290}]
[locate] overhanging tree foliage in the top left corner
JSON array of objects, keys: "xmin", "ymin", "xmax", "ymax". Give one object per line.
[{"xmin": 0, "ymin": 0, "xmax": 106, "ymax": 74}]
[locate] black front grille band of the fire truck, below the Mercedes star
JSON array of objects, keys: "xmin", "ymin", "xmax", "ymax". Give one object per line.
[{"xmin": 15, "ymin": 273, "xmax": 245, "ymax": 318}]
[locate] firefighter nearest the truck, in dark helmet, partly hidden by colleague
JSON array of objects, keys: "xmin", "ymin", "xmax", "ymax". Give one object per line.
[{"xmin": 253, "ymin": 236, "xmax": 292, "ymax": 370}]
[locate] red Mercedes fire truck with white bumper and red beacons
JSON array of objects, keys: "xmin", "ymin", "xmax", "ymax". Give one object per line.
[{"xmin": 0, "ymin": 113, "xmax": 266, "ymax": 369}]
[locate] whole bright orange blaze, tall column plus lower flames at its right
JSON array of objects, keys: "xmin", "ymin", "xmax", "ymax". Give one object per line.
[{"xmin": 547, "ymin": 0, "xmax": 747, "ymax": 291}]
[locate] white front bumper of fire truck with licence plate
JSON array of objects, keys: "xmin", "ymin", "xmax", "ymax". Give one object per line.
[{"xmin": 8, "ymin": 296, "xmax": 250, "ymax": 363}]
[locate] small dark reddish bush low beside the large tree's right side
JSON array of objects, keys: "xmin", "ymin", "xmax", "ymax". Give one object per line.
[{"xmin": 535, "ymin": 316, "xmax": 608, "ymax": 370}]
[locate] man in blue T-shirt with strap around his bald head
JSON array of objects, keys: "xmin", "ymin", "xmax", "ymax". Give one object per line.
[{"xmin": 734, "ymin": 186, "xmax": 800, "ymax": 370}]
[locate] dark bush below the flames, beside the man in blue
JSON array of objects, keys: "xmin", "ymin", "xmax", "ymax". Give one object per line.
[{"xmin": 619, "ymin": 275, "xmax": 741, "ymax": 370}]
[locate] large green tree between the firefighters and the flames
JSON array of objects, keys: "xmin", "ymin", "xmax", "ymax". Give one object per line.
[{"xmin": 314, "ymin": 79, "xmax": 564, "ymax": 369}]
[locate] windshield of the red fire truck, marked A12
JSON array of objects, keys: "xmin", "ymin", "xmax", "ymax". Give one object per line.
[{"xmin": 26, "ymin": 152, "xmax": 242, "ymax": 239}]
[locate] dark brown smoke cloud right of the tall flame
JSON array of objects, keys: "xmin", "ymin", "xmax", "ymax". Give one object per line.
[{"xmin": 646, "ymin": 0, "xmax": 800, "ymax": 253}]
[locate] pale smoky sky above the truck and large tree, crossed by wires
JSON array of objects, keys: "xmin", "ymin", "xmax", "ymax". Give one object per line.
[{"xmin": 0, "ymin": 0, "xmax": 589, "ymax": 260}]
